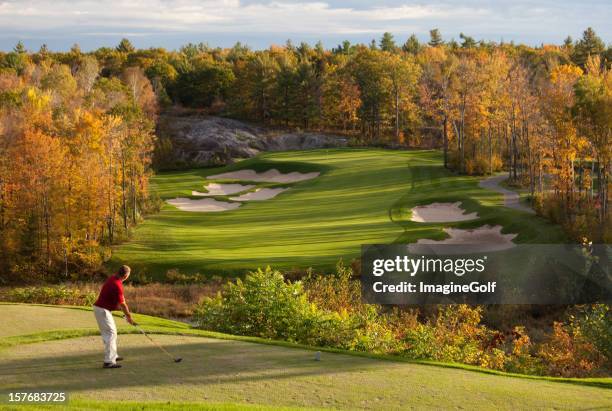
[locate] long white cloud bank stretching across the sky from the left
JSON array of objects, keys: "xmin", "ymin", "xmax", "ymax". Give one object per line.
[{"xmin": 0, "ymin": 0, "xmax": 483, "ymax": 33}]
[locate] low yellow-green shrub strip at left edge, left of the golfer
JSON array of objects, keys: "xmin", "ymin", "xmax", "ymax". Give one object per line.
[{"xmin": 6, "ymin": 285, "xmax": 96, "ymax": 306}]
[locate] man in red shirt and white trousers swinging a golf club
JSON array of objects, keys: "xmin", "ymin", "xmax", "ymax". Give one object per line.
[{"xmin": 93, "ymin": 265, "xmax": 134, "ymax": 368}]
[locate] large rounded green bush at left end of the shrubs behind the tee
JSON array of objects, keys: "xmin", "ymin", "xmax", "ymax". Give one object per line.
[{"xmin": 194, "ymin": 267, "xmax": 397, "ymax": 352}]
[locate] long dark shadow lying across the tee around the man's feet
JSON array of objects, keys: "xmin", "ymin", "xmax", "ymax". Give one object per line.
[{"xmin": 0, "ymin": 335, "xmax": 382, "ymax": 393}]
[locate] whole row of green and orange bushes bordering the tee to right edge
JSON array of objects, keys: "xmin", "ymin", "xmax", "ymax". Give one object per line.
[{"xmin": 194, "ymin": 264, "xmax": 612, "ymax": 376}]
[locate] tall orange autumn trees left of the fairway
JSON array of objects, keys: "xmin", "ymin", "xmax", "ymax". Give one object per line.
[{"xmin": 0, "ymin": 44, "xmax": 157, "ymax": 282}]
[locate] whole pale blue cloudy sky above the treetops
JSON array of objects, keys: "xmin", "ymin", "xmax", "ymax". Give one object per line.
[{"xmin": 0, "ymin": 0, "xmax": 612, "ymax": 51}]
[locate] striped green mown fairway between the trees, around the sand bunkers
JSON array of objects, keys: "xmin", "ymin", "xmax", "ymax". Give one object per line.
[{"xmin": 113, "ymin": 149, "xmax": 562, "ymax": 278}]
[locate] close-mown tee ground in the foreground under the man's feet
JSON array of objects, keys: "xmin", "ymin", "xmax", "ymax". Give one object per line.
[{"xmin": 0, "ymin": 305, "xmax": 612, "ymax": 410}]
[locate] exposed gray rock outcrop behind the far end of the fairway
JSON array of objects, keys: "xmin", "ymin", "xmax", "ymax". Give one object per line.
[{"xmin": 159, "ymin": 115, "xmax": 347, "ymax": 166}]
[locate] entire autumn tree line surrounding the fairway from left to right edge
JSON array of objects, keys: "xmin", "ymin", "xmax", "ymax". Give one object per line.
[{"xmin": 0, "ymin": 28, "xmax": 612, "ymax": 282}]
